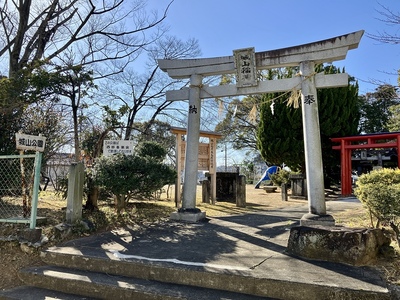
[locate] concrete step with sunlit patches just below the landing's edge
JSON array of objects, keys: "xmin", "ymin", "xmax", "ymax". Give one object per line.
[{"xmin": 12, "ymin": 266, "xmax": 268, "ymax": 300}]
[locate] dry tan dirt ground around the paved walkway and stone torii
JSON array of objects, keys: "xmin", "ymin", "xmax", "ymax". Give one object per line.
[{"xmin": 0, "ymin": 185, "xmax": 400, "ymax": 289}]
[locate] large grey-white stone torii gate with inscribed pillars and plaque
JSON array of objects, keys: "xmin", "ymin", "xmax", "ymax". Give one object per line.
[{"xmin": 158, "ymin": 30, "xmax": 364, "ymax": 225}]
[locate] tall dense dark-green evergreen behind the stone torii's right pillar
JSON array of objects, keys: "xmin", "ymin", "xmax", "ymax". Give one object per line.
[{"xmin": 257, "ymin": 65, "xmax": 360, "ymax": 183}]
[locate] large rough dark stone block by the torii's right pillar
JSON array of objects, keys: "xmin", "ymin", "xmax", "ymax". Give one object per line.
[{"xmin": 287, "ymin": 226, "xmax": 390, "ymax": 266}]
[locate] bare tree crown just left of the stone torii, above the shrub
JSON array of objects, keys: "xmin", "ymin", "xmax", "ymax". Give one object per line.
[{"xmin": 102, "ymin": 36, "xmax": 200, "ymax": 140}]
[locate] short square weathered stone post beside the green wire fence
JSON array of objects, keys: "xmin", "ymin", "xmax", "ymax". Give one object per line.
[{"xmin": 66, "ymin": 163, "xmax": 84, "ymax": 224}]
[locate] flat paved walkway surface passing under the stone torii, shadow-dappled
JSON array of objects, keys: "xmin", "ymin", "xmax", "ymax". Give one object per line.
[{"xmin": 57, "ymin": 198, "xmax": 394, "ymax": 299}]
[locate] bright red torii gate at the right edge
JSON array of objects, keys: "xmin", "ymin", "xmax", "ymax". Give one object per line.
[{"xmin": 331, "ymin": 132, "xmax": 400, "ymax": 195}]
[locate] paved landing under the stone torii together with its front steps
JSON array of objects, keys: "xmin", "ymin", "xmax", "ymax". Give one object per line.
[{"xmin": 0, "ymin": 209, "xmax": 394, "ymax": 300}]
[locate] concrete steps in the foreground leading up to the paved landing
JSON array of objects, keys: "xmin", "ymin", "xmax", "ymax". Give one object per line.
[{"xmin": 0, "ymin": 247, "xmax": 391, "ymax": 300}]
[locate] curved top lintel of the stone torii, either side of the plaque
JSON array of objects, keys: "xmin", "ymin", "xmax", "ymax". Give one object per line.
[{"xmin": 158, "ymin": 30, "xmax": 364, "ymax": 79}]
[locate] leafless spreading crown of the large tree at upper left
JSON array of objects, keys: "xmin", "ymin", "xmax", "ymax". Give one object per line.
[{"xmin": 0, "ymin": 0, "xmax": 173, "ymax": 76}]
